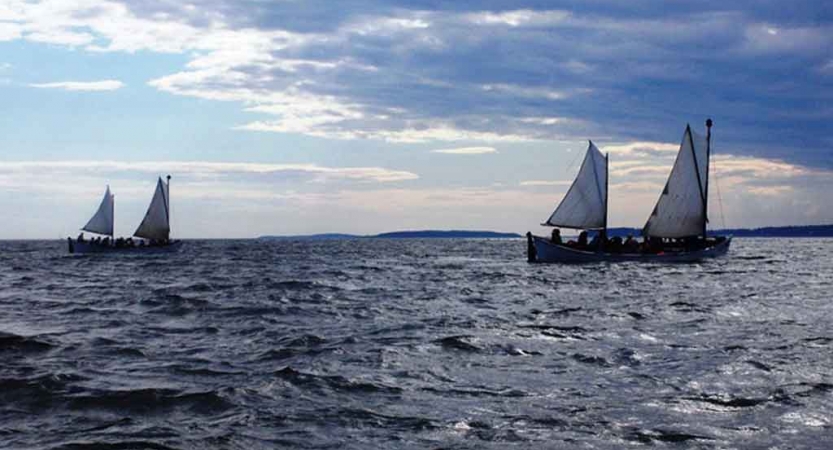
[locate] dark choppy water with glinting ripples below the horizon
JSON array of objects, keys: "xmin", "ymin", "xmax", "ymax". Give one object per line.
[{"xmin": 0, "ymin": 240, "xmax": 833, "ymax": 450}]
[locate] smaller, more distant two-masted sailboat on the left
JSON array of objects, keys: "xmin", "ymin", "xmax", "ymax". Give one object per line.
[{"xmin": 67, "ymin": 175, "xmax": 182, "ymax": 253}]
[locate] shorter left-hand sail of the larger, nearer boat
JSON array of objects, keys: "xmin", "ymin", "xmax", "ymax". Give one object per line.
[{"xmin": 547, "ymin": 142, "xmax": 607, "ymax": 229}]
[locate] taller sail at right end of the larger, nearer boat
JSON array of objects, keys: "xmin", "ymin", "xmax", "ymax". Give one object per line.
[{"xmin": 643, "ymin": 126, "xmax": 708, "ymax": 238}]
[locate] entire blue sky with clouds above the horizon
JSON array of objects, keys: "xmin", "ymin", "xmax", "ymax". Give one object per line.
[{"xmin": 0, "ymin": 0, "xmax": 833, "ymax": 239}]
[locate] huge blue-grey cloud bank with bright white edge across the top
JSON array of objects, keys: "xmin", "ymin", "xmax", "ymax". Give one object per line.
[{"xmin": 0, "ymin": 0, "xmax": 833, "ymax": 167}]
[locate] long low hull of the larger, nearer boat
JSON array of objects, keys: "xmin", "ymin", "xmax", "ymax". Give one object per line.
[{"xmin": 527, "ymin": 235, "xmax": 732, "ymax": 263}]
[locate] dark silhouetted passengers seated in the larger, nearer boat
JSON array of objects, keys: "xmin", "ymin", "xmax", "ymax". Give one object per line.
[{"xmin": 550, "ymin": 228, "xmax": 725, "ymax": 254}]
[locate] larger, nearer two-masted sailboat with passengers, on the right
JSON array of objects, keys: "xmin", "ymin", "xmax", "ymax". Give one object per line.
[{"xmin": 527, "ymin": 119, "xmax": 732, "ymax": 263}]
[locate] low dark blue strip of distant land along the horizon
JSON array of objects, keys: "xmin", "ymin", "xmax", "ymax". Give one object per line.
[{"xmin": 258, "ymin": 224, "xmax": 833, "ymax": 240}]
